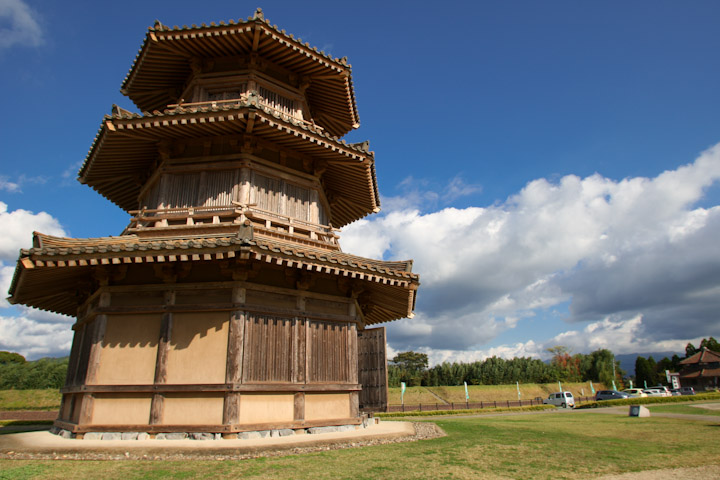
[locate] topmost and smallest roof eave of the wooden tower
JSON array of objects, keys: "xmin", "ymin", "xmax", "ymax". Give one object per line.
[{"xmin": 121, "ymin": 19, "xmax": 360, "ymax": 137}]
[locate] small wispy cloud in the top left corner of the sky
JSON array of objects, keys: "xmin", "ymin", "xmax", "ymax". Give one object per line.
[{"xmin": 0, "ymin": 0, "xmax": 45, "ymax": 49}]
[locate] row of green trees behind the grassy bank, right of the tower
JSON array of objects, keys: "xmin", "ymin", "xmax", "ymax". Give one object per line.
[{"xmin": 388, "ymin": 346, "xmax": 624, "ymax": 387}]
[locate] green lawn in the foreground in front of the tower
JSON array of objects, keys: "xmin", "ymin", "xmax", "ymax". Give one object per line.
[{"xmin": 0, "ymin": 407, "xmax": 720, "ymax": 480}]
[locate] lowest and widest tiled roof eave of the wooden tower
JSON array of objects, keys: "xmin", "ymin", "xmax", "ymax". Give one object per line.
[{"xmin": 9, "ymin": 234, "xmax": 419, "ymax": 325}]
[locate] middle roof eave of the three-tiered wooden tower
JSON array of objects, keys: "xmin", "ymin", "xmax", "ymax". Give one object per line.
[{"xmin": 78, "ymin": 106, "xmax": 380, "ymax": 228}]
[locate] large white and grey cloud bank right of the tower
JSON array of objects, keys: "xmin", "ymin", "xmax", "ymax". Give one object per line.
[{"xmin": 342, "ymin": 145, "xmax": 720, "ymax": 358}]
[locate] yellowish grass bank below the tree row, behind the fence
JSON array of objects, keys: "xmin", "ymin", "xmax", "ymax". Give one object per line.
[{"xmin": 388, "ymin": 382, "xmax": 605, "ymax": 405}]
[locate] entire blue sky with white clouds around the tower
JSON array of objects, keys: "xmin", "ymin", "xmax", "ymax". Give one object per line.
[{"xmin": 0, "ymin": 0, "xmax": 720, "ymax": 362}]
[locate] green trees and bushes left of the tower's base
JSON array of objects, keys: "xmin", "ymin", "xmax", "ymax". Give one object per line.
[{"xmin": 0, "ymin": 352, "xmax": 68, "ymax": 390}]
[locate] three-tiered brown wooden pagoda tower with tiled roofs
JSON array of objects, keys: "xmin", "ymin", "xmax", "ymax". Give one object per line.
[{"xmin": 10, "ymin": 9, "xmax": 419, "ymax": 438}]
